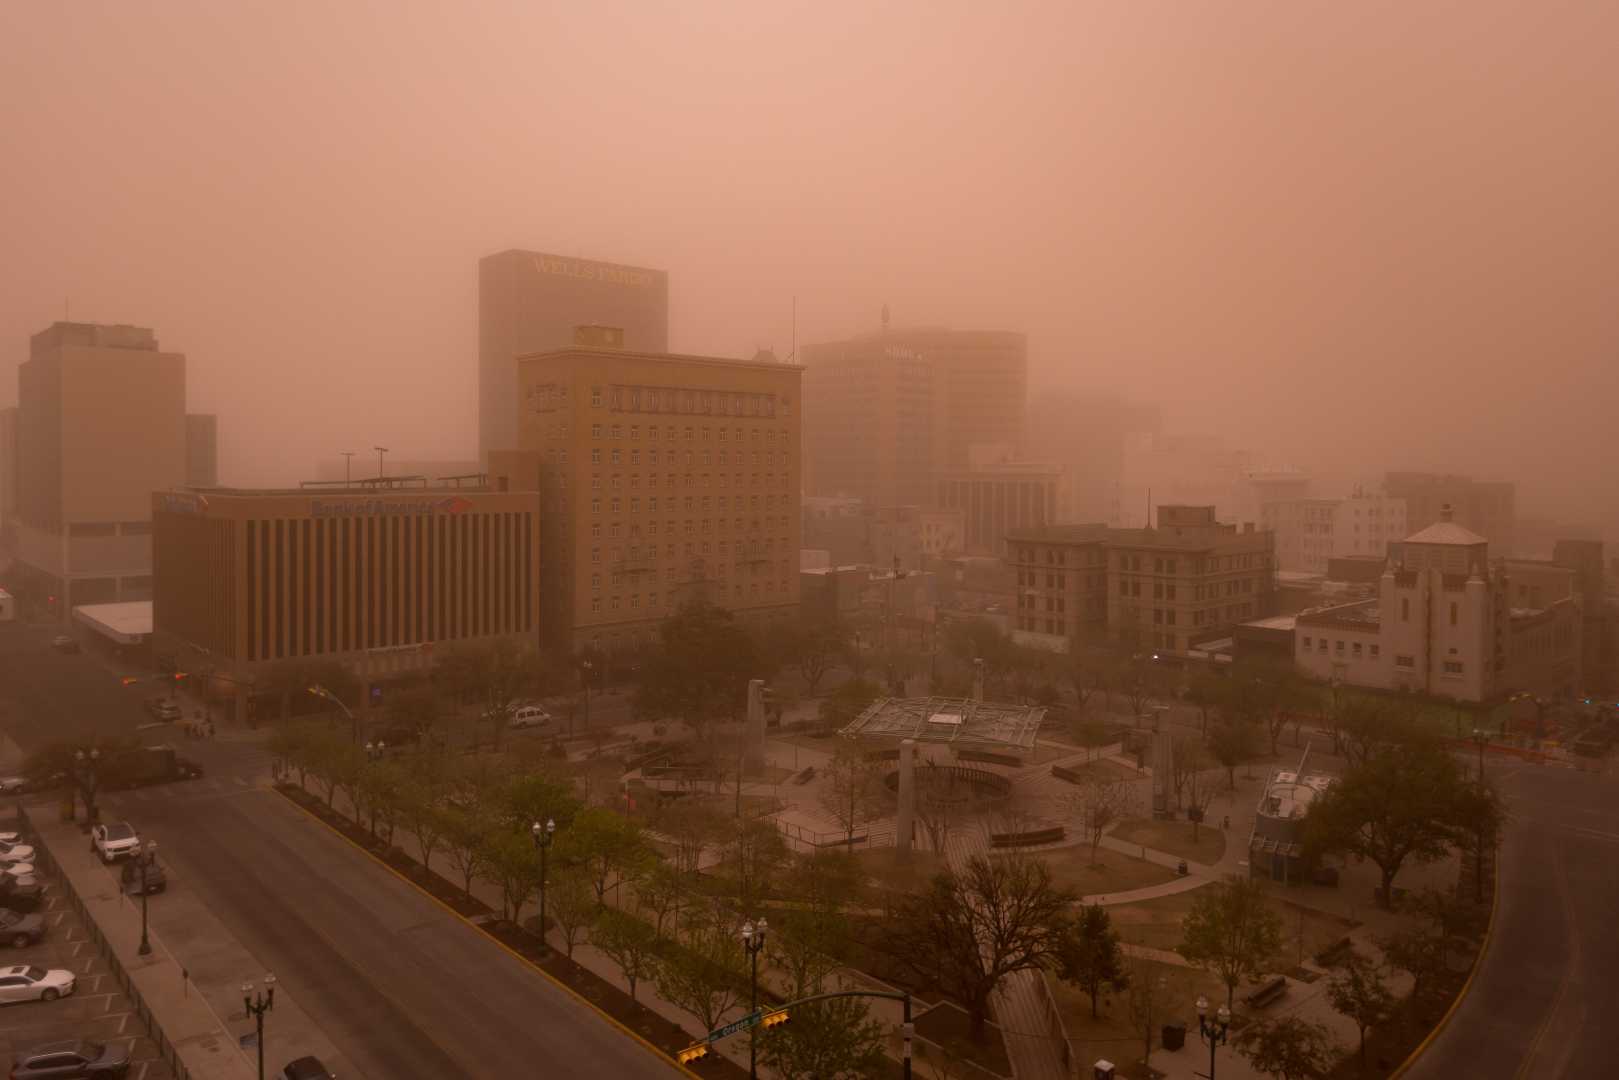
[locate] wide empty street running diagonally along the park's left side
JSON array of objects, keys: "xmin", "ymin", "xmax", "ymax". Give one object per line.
[{"xmin": 0, "ymin": 625, "xmax": 675, "ymax": 1080}]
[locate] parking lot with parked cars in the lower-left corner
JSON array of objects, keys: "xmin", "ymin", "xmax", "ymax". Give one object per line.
[{"xmin": 0, "ymin": 876, "xmax": 173, "ymax": 1080}]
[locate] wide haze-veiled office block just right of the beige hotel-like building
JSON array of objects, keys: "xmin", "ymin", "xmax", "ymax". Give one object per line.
[{"xmin": 803, "ymin": 327, "xmax": 1028, "ymax": 505}]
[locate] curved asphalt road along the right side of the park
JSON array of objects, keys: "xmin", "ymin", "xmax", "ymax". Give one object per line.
[{"xmin": 1407, "ymin": 766, "xmax": 1619, "ymax": 1080}]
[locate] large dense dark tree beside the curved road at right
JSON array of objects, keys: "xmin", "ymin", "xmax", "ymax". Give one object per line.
[{"xmin": 1305, "ymin": 740, "xmax": 1467, "ymax": 907}]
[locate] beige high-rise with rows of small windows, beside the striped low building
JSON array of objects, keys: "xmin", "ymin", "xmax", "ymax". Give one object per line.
[{"xmin": 511, "ymin": 327, "xmax": 803, "ymax": 651}]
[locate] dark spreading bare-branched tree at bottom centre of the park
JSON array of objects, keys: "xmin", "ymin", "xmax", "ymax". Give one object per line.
[{"xmin": 881, "ymin": 855, "xmax": 1078, "ymax": 1041}]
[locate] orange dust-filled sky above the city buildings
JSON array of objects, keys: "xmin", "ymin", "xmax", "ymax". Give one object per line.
[{"xmin": 0, "ymin": 3, "xmax": 1619, "ymax": 531}]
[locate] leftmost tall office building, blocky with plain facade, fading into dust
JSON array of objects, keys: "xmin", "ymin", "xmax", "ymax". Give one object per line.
[{"xmin": 15, "ymin": 322, "xmax": 186, "ymax": 617}]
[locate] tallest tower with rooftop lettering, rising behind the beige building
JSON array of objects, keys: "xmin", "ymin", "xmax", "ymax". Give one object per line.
[{"xmin": 478, "ymin": 249, "xmax": 669, "ymax": 461}]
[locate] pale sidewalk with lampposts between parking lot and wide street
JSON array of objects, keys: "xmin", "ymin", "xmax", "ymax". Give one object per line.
[{"xmin": 29, "ymin": 803, "xmax": 348, "ymax": 1080}]
